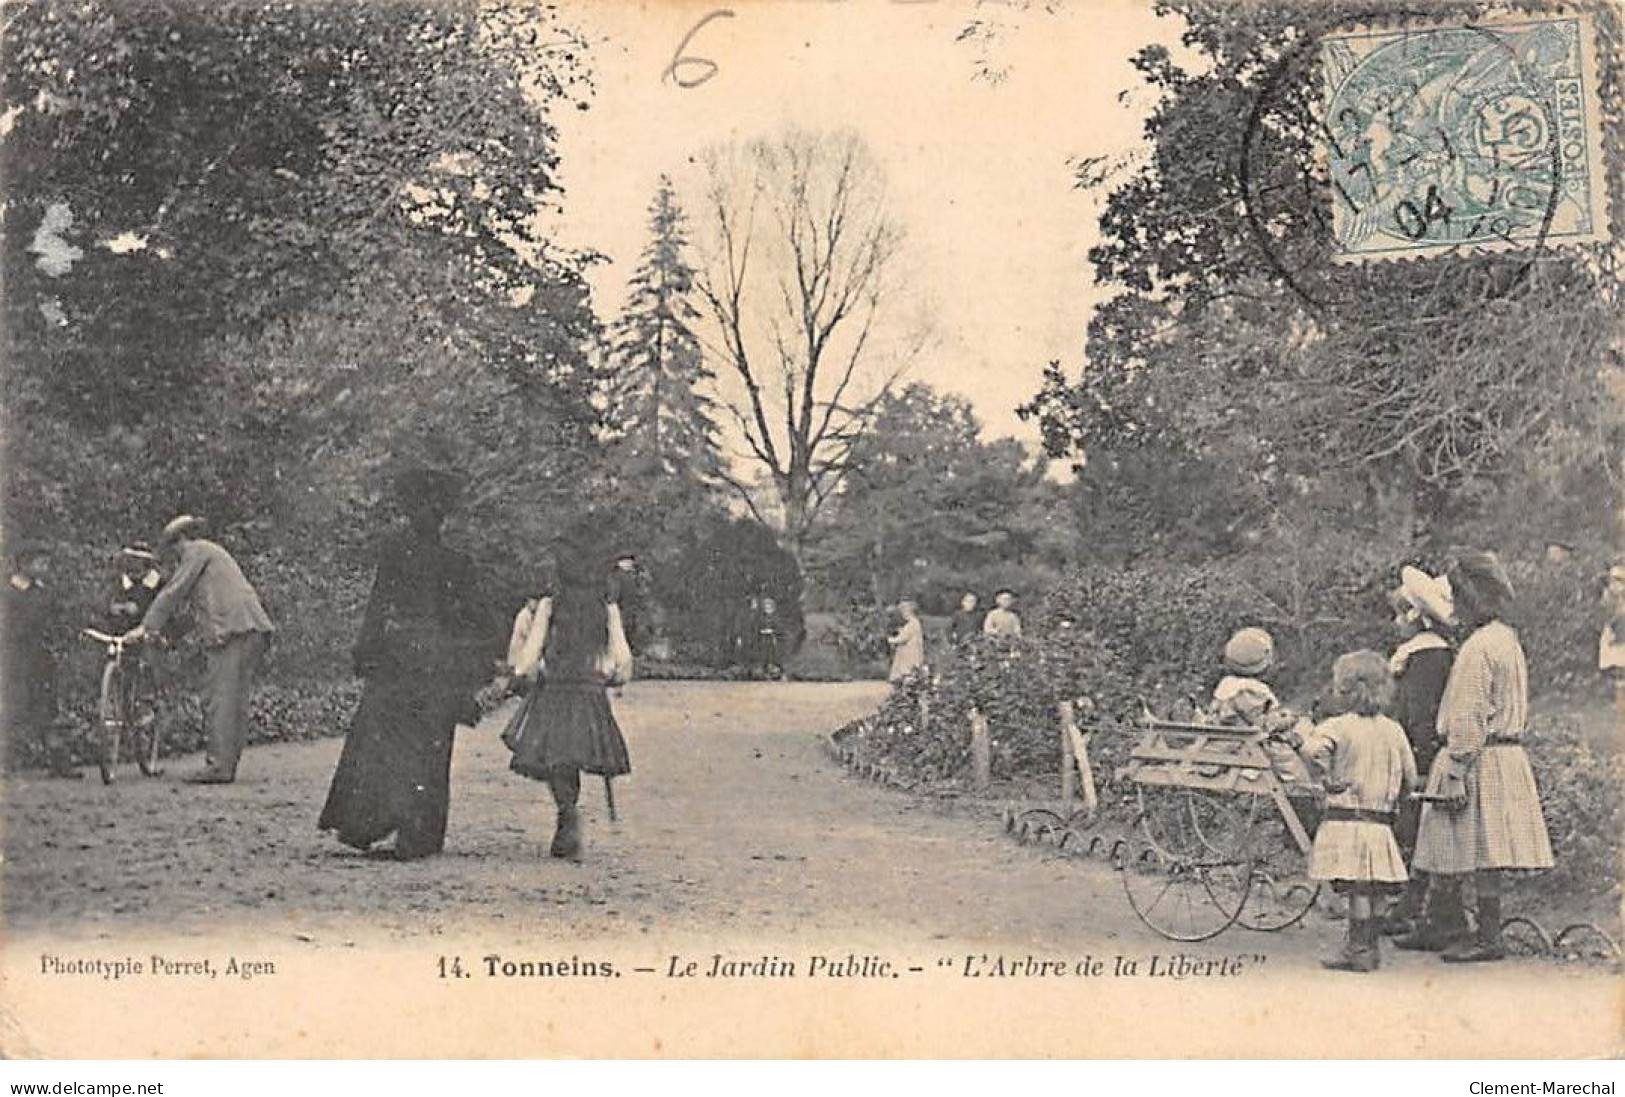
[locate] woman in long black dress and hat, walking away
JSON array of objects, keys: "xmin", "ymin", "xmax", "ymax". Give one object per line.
[{"xmin": 317, "ymin": 468, "xmax": 486, "ymax": 861}]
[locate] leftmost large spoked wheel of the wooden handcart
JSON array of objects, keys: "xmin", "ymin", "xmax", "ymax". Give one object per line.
[{"xmin": 1121, "ymin": 816, "xmax": 1253, "ymax": 941}]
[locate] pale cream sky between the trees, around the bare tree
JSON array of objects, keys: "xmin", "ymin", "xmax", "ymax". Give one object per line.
[{"xmin": 557, "ymin": 0, "xmax": 1178, "ymax": 442}]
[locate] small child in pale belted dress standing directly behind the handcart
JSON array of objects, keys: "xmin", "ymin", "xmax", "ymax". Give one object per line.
[{"xmin": 1285, "ymin": 652, "xmax": 1417, "ymax": 972}]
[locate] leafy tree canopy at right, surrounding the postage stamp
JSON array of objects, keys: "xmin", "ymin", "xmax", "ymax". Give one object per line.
[{"xmin": 1027, "ymin": 0, "xmax": 1625, "ymax": 546}]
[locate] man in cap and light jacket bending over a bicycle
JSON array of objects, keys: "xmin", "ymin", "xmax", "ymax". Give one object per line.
[{"xmin": 125, "ymin": 514, "xmax": 276, "ymax": 785}]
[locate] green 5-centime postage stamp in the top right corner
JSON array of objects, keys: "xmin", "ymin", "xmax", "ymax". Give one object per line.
[{"xmin": 1320, "ymin": 13, "xmax": 1609, "ymax": 262}]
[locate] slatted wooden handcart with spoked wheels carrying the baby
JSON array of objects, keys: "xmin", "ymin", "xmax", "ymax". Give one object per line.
[{"xmin": 1120, "ymin": 718, "xmax": 1321, "ymax": 941}]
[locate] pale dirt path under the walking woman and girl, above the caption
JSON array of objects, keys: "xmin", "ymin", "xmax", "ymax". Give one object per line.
[{"xmin": 3, "ymin": 683, "xmax": 1599, "ymax": 965}]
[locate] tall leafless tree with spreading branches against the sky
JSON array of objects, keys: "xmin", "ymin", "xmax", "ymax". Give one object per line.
[{"xmin": 699, "ymin": 132, "xmax": 920, "ymax": 561}]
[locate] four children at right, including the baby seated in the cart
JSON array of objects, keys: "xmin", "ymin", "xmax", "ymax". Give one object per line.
[{"xmin": 1211, "ymin": 551, "xmax": 1552, "ymax": 972}]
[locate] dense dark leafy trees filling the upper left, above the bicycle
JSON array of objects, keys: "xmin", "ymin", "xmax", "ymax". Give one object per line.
[{"xmin": 0, "ymin": 0, "xmax": 600, "ymax": 747}]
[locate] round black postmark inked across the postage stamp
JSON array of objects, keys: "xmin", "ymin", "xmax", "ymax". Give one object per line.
[{"xmin": 1238, "ymin": 11, "xmax": 1578, "ymax": 310}]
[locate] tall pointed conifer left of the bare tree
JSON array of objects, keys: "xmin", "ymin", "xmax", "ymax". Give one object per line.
[{"xmin": 606, "ymin": 176, "xmax": 723, "ymax": 513}]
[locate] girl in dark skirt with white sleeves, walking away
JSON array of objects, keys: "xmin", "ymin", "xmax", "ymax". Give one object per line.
[{"xmin": 502, "ymin": 546, "xmax": 632, "ymax": 860}]
